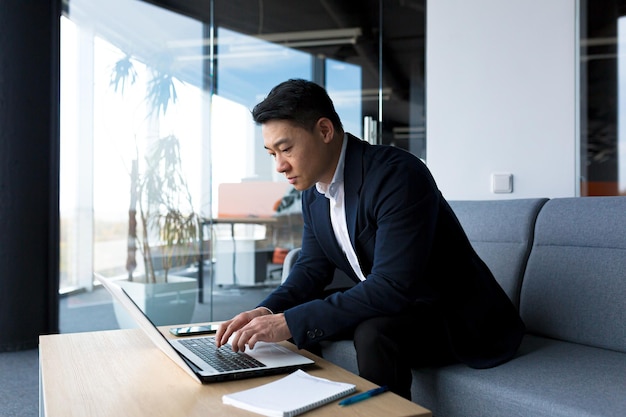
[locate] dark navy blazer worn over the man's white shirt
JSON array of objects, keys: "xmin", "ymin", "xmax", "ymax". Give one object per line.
[{"xmin": 260, "ymin": 134, "xmax": 524, "ymax": 368}]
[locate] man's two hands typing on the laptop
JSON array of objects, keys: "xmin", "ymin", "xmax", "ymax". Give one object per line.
[{"xmin": 215, "ymin": 307, "xmax": 291, "ymax": 352}]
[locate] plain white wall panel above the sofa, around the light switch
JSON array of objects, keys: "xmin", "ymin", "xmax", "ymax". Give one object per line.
[{"xmin": 426, "ymin": 0, "xmax": 579, "ymax": 200}]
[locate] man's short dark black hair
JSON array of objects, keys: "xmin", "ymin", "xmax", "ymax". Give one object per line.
[{"xmin": 252, "ymin": 79, "xmax": 343, "ymax": 133}]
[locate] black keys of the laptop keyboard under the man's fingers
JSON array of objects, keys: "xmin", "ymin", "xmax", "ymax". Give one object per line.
[{"xmin": 180, "ymin": 337, "xmax": 265, "ymax": 372}]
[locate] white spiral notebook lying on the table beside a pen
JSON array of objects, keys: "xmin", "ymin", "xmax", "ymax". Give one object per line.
[{"xmin": 222, "ymin": 370, "xmax": 356, "ymax": 417}]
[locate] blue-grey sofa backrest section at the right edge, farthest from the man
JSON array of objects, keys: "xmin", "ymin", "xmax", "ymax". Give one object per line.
[{"xmin": 520, "ymin": 197, "xmax": 626, "ymax": 352}]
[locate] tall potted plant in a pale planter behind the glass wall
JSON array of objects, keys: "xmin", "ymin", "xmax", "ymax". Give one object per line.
[{"xmin": 111, "ymin": 55, "xmax": 200, "ymax": 327}]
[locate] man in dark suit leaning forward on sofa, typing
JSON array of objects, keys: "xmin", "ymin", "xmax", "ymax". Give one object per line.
[{"xmin": 216, "ymin": 80, "xmax": 524, "ymax": 398}]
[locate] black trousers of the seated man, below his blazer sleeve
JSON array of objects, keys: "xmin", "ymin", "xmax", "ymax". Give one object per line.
[{"xmin": 353, "ymin": 304, "xmax": 456, "ymax": 400}]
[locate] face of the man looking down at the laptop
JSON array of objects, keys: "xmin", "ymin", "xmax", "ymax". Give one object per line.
[{"xmin": 262, "ymin": 119, "xmax": 337, "ymax": 191}]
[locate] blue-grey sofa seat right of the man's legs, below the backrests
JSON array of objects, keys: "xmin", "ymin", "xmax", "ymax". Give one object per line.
[{"xmin": 411, "ymin": 335, "xmax": 626, "ymax": 417}]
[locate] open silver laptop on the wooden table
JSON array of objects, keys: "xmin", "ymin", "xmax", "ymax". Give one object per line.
[{"xmin": 94, "ymin": 274, "xmax": 314, "ymax": 383}]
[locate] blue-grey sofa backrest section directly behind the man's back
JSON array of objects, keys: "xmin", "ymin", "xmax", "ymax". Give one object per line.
[{"xmin": 450, "ymin": 198, "xmax": 547, "ymax": 306}]
